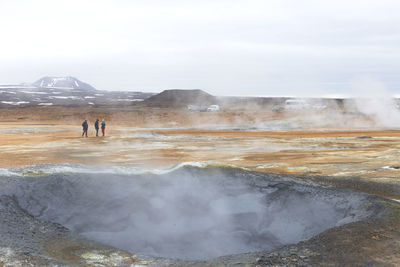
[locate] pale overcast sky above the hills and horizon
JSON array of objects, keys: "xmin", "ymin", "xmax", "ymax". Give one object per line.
[{"xmin": 0, "ymin": 0, "xmax": 400, "ymax": 96}]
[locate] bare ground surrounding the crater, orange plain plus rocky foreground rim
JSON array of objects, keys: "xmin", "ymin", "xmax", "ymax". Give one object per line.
[{"xmin": 0, "ymin": 106, "xmax": 400, "ymax": 266}]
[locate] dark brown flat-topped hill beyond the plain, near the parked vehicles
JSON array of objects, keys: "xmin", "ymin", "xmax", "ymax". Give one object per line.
[{"xmin": 145, "ymin": 89, "xmax": 217, "ymax": 107}]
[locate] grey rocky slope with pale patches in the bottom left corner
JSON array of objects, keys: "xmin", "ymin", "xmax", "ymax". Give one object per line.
[{"xmin": 0, "ymin": 195, "xmax": 144, "ymax": 266}]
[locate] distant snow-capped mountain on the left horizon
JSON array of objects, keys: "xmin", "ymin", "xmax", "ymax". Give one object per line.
[{"xmin": 32, "ymin": 76, "xmax": 96, "ymax": 90}]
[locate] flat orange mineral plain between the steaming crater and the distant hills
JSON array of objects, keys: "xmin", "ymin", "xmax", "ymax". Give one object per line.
[{"xmin": 0, "ymin": 107, "xmax": 400, "ymax": 199}]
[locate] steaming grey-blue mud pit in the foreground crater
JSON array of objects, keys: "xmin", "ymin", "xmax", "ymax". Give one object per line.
[{"xmin": 0, "ymin": 167, "xmax": 372, "ymax": 259}]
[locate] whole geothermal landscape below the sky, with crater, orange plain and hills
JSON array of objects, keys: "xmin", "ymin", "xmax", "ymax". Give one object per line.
[{"xmin": 0, "ymin": 84, "xmax": 400, "ymax": 266}]
